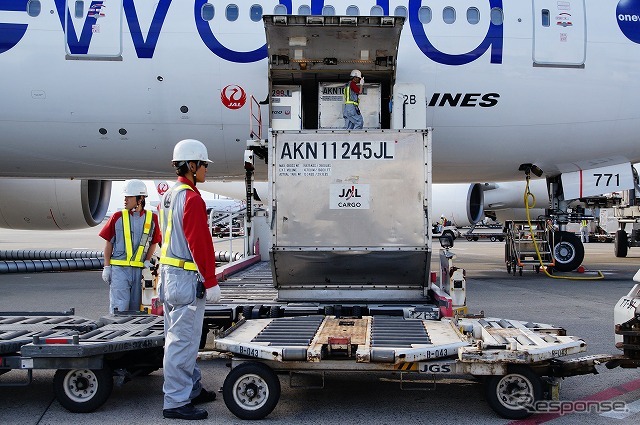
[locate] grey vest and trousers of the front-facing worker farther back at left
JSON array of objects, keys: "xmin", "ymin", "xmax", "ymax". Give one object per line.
[{"xmin": 109, "ymin": 211, "xmax": 155, "ymax": 313}]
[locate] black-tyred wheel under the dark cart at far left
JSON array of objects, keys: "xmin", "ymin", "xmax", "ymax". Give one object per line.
[{"xmin": 53, "ymin": 368, "xmax": 113, "ymax": 413}]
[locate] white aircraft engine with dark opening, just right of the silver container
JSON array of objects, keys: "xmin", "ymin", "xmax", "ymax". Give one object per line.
[{"xmin": 431, "ymin": 183, "xmax": 484, "ymax": 227}]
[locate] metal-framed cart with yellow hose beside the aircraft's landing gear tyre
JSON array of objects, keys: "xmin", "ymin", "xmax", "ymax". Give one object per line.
[{"xmin": 504, "ymin": 220, "xmax": 555, "ymax": 276}]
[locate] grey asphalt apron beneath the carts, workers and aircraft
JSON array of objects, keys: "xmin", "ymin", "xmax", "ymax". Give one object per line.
[{"xmin": 0, "ymin": 229, "xmax": 640, "ymax": 425}]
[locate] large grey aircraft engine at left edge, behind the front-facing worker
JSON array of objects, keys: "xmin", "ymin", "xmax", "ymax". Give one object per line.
[{"xmin": 0, "ymin": 179, "xmax": 111, "ymax": 230}]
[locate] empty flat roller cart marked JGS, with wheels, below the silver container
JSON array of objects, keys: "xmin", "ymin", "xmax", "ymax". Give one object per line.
[{"xmin": 214, "ymin": 316, "xmax": 598, "ymax": 419}]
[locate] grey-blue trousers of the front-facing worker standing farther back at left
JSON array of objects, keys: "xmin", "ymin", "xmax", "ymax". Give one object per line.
[{"xmin": 109, "ymin": 266, "xmax": 142, "ymax": 313}]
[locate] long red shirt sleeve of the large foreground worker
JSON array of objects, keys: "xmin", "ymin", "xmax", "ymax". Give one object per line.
[{"xmin": 178, "ymin": 177, "xmax": 218, "ymax": 288}]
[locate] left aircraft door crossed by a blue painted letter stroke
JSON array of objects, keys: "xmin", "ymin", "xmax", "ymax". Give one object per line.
[{"xmin": 64, "ymin": 0, "xmax": 123, "ymax": 60}]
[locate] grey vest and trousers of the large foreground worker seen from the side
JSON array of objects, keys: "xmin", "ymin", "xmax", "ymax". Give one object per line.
[{"xmin": 159, "ymin": 185, "xmax": 206, "ymax": 409}]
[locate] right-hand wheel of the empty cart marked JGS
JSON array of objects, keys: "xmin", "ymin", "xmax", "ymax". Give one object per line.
[{"xmin": 485, "ymin": 366, "xmax": 542, "ymax": 419}]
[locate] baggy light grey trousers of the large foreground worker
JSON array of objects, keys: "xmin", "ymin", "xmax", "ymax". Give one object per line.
[{"xmin": 160, "ymin": 264, "xmax": 206, "ymax": 409}]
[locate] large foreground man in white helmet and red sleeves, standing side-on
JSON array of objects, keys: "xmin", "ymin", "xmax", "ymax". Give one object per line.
[{"xmin": 160, "ymin": 139, "xmax": 220, "ymax": 419}]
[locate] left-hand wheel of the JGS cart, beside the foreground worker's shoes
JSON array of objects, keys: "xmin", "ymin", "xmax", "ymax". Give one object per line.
[{"xmin": 222, "ymin": 362, "xmax": 280, "ymax": 419}]
